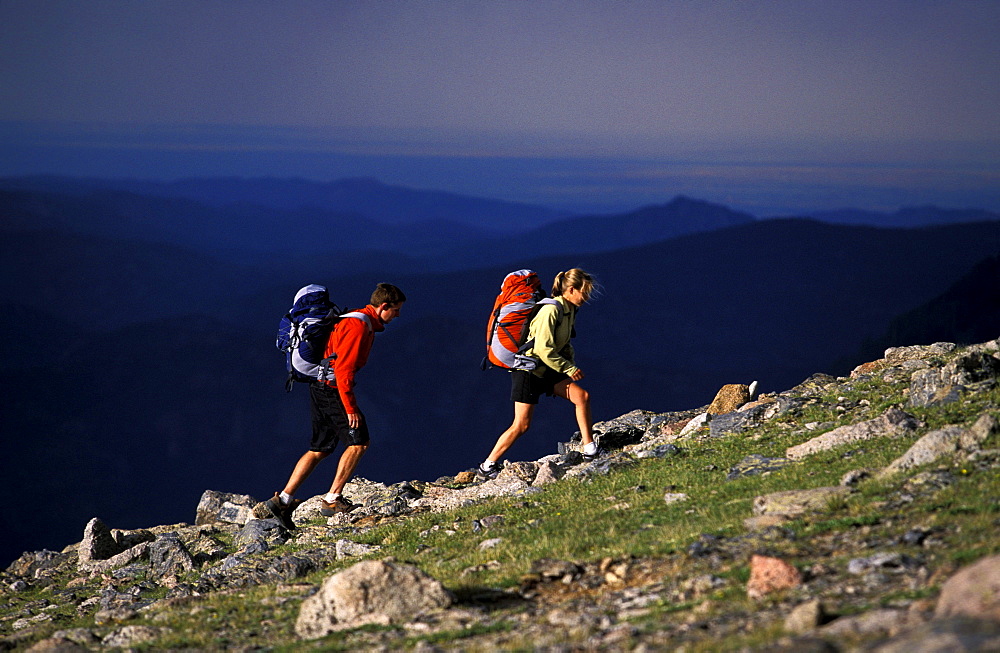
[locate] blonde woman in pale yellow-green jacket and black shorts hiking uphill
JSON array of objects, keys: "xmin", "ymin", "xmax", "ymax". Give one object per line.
[{"xmin": 479, "ymin": 268, "xmax": 603, "ymax": 478}]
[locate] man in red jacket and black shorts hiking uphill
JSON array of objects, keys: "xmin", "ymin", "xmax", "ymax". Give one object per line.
[{"xmin": 260, "ymin": 283, "xmax": 406, "ymax": 528}]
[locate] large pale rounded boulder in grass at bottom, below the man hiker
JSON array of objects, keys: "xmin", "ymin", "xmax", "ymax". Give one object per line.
[{"xmin": 295, "ymin": 560, "xmax": 454, "ymax": 639}]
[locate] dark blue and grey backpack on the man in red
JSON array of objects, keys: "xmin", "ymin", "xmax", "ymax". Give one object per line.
[{"xmin": 275, "ymin": 284, "xmax": 371, "ymax": 392}]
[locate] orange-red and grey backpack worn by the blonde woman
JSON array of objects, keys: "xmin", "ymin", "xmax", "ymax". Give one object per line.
[{"xmin": 482, "ymin": 270, "xmax": 555, "ymax": 370}]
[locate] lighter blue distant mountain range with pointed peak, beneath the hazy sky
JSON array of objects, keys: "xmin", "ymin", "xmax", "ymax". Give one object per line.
[{"xmin": 0, "ymin": 180, "xmax": 754, "ymax": 271}]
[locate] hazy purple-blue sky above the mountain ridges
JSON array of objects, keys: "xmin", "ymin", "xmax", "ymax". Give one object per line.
[{"xmin": 0, "ymin": 0, "xmax": 1000, "ymax": 212}]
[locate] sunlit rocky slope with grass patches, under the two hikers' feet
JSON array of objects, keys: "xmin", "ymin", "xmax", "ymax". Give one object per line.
[{"xmin": 0, "ymin": 340, "xmax": 1000, "ymax": 651}]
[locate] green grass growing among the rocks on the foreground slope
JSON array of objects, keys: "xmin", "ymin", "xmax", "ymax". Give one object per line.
[{"xmin": 3, "ymin": 344, "xmax": 1000, "ymax": 650}]
